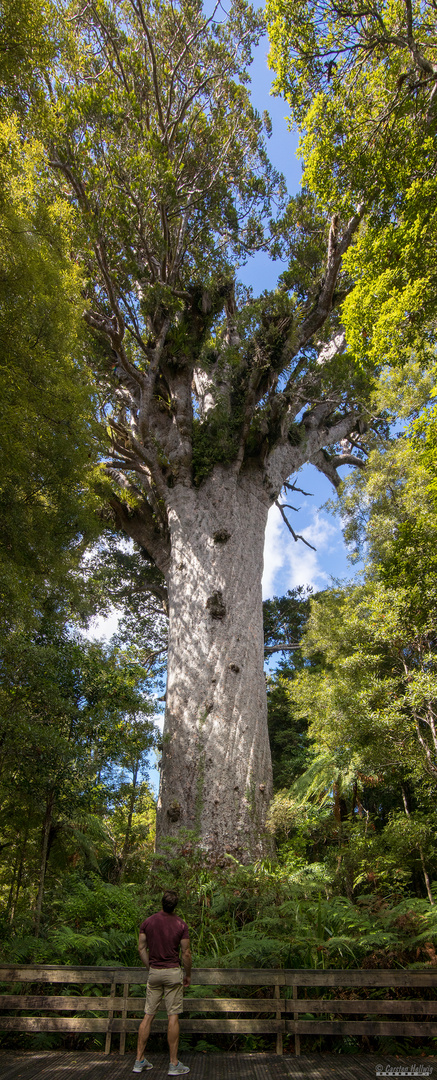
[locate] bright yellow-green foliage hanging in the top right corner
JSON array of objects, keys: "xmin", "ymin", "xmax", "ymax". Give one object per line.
[{"xmin": 267, "ymin": 0, "xmax": 436, "ymax": 375}]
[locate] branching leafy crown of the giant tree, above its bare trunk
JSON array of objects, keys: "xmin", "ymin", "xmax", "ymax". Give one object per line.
[{"xmin": 22, "ymin": 2, "xmax": 377, "ymax": 559}]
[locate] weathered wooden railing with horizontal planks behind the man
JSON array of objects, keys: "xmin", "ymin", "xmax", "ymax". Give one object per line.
[{"xmin": 0, "ymin": 964, "xmax": 437, "ymax": 1054}]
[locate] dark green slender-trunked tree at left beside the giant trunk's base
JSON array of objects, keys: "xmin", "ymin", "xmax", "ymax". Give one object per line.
[{"xmin": 0, "ymin": 620, "xmax": 154, "ymax": 935}]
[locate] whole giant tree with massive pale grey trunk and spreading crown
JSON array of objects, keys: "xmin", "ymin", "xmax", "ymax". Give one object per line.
[{"xmin": 36, "ymin": 0, "xmax": 375, "ymax": 859}]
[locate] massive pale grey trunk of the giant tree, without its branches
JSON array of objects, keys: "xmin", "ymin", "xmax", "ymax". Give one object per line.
[{"xmin": 156, "ymin": 467, "xmax": 272, "ymax": 860}]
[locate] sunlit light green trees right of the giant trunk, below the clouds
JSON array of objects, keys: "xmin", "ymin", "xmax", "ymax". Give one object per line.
[{"xmin": 265, "ymin": 397, "xmax": 436, "ymax": 904}]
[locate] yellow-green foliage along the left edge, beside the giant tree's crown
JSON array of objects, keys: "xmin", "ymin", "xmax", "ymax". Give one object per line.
[{"xmin": 0, "ymin": 118, "xmax": 101, "ymax": 626}]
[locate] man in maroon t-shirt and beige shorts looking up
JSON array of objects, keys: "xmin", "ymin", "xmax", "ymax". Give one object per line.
[{"xmin": 134, "ymin": 889, "xmax": 191, "ymax": 1077}]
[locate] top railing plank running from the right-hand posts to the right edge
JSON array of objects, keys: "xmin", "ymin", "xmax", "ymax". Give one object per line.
[{"xmin": 284, "ymin": 968, "xmax": 437, "ymax": 987}]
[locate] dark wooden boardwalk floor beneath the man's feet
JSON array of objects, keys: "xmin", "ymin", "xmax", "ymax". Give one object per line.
[{"xmin": 0, "ymin": 1050, "xmax": 437, "ymax": 1080}]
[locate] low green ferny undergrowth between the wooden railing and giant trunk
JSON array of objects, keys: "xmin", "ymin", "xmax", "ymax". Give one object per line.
[{"xmin": 1, "ymin": 833, "xmax": 437, "ymax": 968}]
